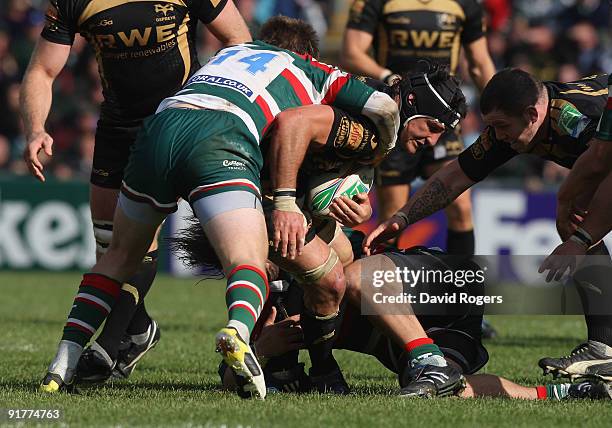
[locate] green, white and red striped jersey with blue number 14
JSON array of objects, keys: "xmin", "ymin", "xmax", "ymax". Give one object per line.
[{"xmin": 157, "ymin": 41, "xmax": 399, "ymax": 150}]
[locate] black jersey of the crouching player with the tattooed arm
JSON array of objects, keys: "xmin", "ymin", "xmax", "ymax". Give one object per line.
[{"xmin": 458, "ymin": 74, "xmax": 608, "ymax": 181}]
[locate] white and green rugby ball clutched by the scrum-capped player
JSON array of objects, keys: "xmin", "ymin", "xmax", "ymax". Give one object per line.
[{"xmin": 306, "ymin": 166, "xmax": 374, "ymax": 217}]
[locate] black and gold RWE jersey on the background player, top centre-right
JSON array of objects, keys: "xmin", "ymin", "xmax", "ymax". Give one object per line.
[{"xmin": 347, "ymin": 0, "xmax": 485, "ymax": 73}]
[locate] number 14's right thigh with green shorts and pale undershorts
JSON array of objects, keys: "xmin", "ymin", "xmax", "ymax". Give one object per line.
[{"xmin": 170, "ymin": 109, "xmax": 268, "ymax": 273}]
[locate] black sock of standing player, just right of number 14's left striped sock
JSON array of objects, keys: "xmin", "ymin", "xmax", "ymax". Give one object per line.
[{"xmin": 96, "ymin": 251, "xmax": 157, "ymax": 360}]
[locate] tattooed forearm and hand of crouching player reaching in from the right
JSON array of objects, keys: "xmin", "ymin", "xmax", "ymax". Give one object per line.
[{"xmin": 363, "ymin": 159, "xmax": 476, "ymax": 254}]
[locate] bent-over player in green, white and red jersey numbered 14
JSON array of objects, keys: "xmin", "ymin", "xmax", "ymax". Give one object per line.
[{"xmin": 42, "ymin": 20, "xmax": 399, "ymax": 399}]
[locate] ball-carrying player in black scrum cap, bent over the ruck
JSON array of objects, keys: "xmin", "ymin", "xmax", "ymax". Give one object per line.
[{"xmin": 74, "ymin": 62, "xmax": 465, "ymax": 393}]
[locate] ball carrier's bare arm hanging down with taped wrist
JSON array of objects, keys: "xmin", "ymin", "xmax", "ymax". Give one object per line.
[{"xmin": 268, "ymin": 105, "xmax": 334, "ymax": 260}]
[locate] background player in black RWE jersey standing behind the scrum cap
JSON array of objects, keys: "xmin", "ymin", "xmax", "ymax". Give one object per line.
[{"xmin": 341, "ymin": 0, "xmax": 495, "ymax": 255}]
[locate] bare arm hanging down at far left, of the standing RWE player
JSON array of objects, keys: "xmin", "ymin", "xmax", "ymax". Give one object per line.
[{"xmin": 20, "ymin": 38, "xmax": 70, "ymax": 181}]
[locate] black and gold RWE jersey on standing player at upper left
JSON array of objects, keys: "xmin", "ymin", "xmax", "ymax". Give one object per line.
[{"xmin": 42, "ymin": 0, "xmax": 227, "ymax": 123}]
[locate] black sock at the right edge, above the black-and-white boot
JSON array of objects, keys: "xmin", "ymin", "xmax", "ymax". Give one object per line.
[{"xmin": 574, "ymin": 242, "xmax": 612, "ymax": 346}]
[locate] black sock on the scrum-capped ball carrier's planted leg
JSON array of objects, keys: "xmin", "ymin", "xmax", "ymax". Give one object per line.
[{"xmin": 300, "ymin": 309, "xmax": 340, "ymax": 376}]
